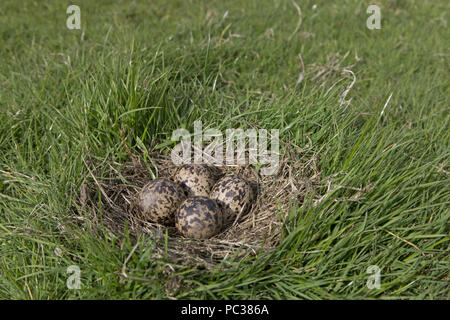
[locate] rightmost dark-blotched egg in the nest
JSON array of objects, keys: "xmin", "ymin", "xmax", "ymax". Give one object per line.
[{"xmin": 210, "ymin": 174, "xmax": 253, "ymax": 225}]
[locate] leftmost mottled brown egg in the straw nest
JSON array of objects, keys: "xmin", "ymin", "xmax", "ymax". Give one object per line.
[{"xmin": 139, "ymin": 178, "xmax": 186, "ymax": 225}]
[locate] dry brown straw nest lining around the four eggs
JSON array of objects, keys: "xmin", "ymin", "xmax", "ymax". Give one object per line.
[{"xmin": 80, "ymin": 151, "xmax": 319, "ymax": 269}]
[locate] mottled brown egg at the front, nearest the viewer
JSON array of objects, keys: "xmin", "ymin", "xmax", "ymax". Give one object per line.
[{"xmin": 175, "ymin": 196, "xmax": 222, "ymax": 239}]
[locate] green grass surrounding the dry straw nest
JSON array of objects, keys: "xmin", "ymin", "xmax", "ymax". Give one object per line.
[{"xmin": 0, "ymin": 0, "xmax": 450, "ymax": 299}]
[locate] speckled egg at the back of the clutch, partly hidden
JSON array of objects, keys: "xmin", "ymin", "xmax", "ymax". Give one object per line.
[{"xmin": 174, "ymin": 164, "xmax": 215, "ymax": 197}]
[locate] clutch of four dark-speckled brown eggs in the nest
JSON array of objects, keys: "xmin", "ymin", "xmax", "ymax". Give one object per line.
[{"xmin": 138, "ymin": 164, "xmax": 254, "ymax": 239}]
